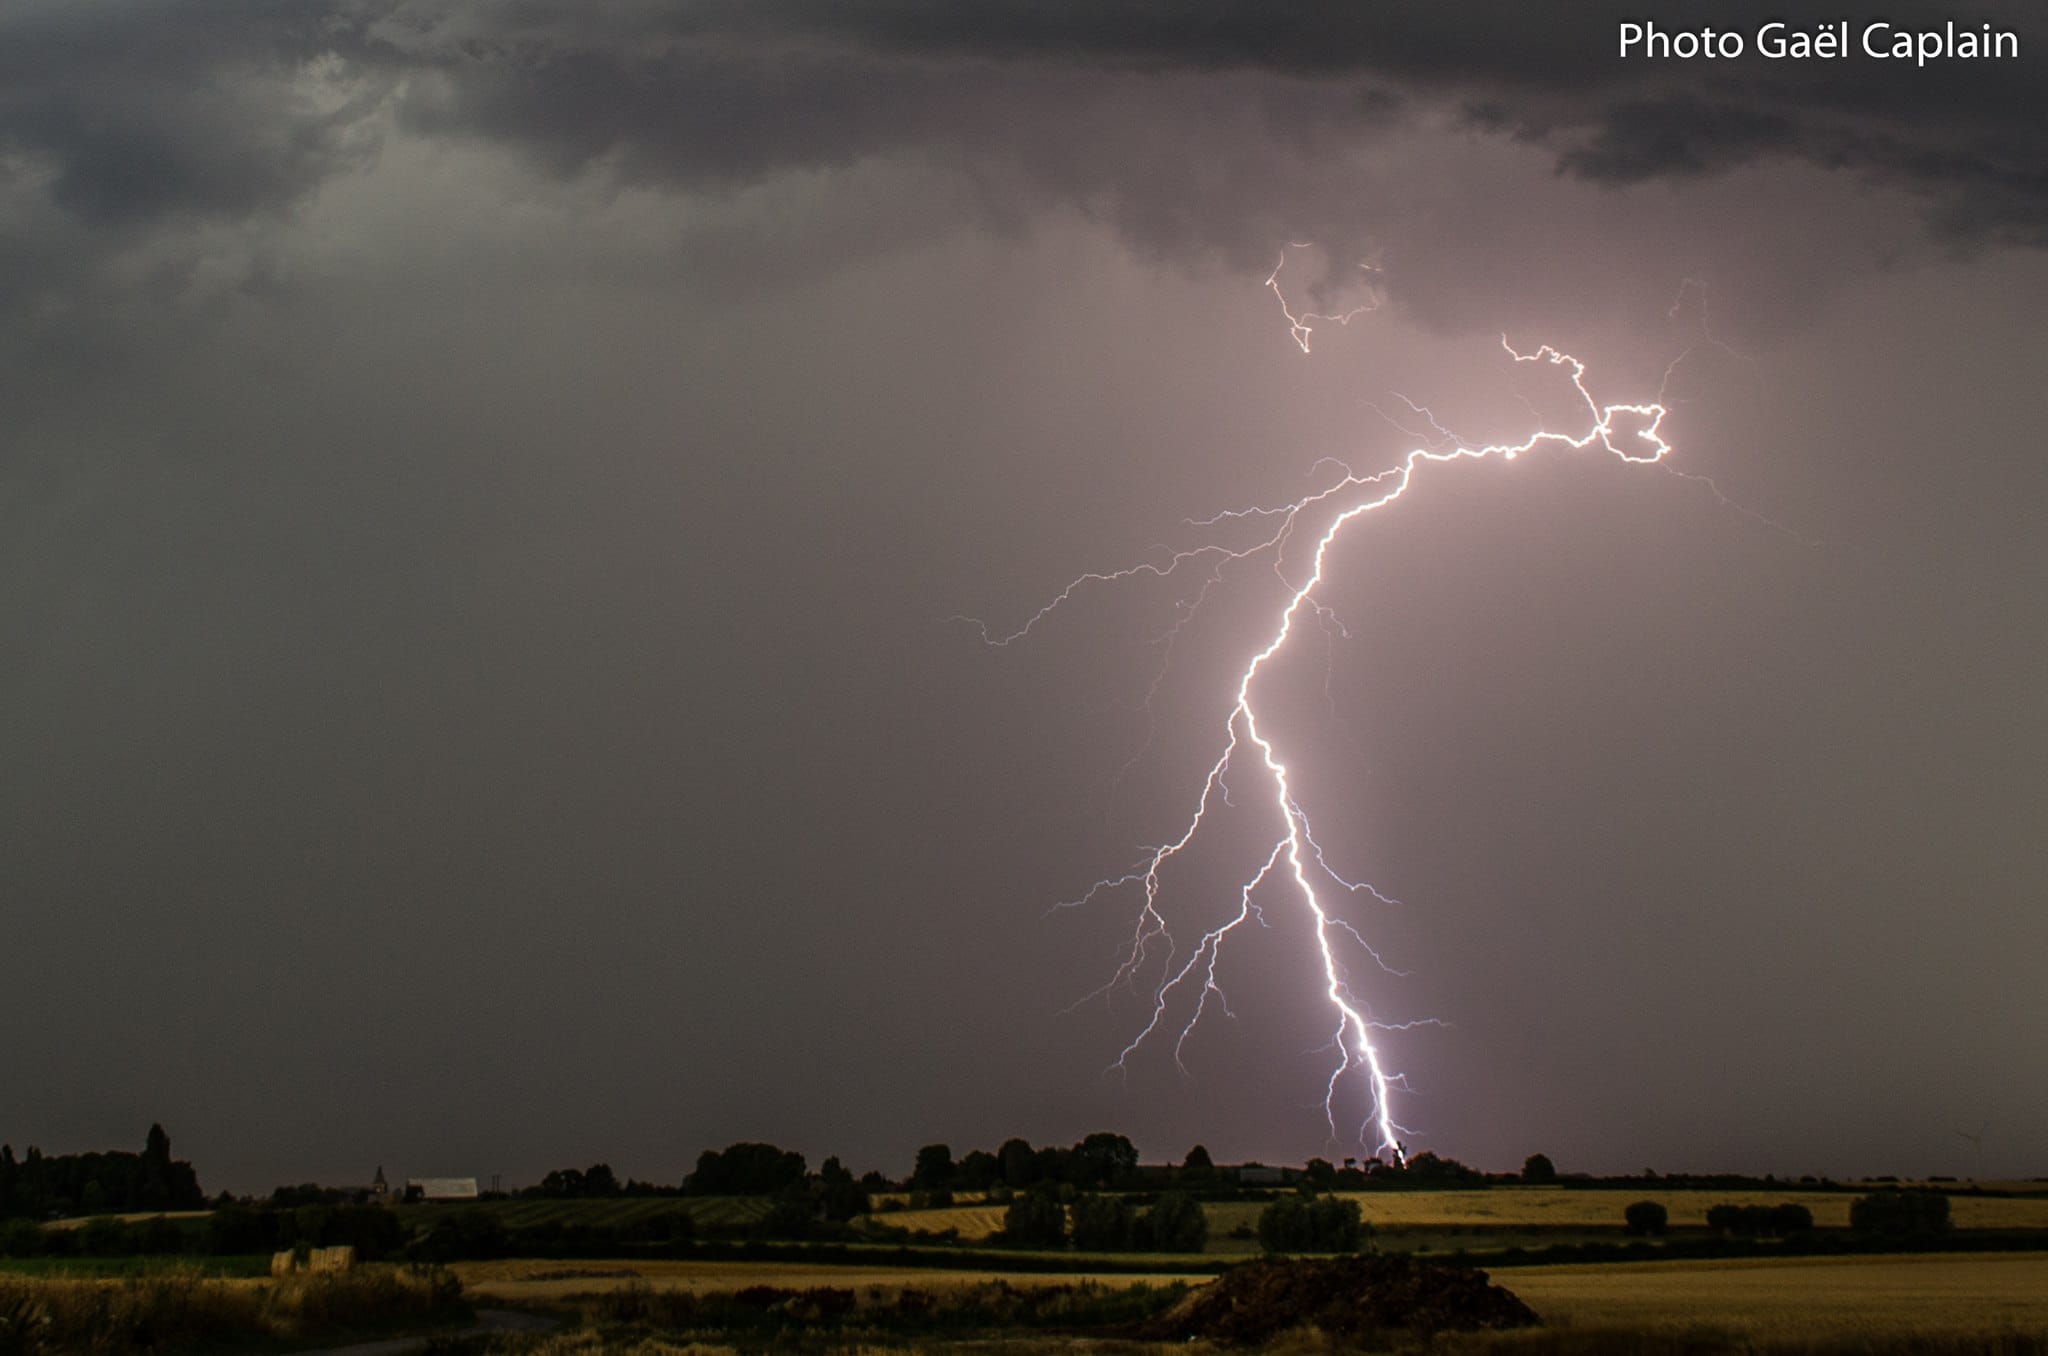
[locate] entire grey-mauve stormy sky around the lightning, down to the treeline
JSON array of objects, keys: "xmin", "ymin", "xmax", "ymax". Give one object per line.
[{"xmin": 0, "ymin": 0, "xmax": 2048, "ymax": 1190}]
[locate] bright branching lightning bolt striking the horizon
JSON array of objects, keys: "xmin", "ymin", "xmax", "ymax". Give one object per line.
[{"xmin": 954, "ymin": 246, "xmax": 1671, "ymax": 1161}]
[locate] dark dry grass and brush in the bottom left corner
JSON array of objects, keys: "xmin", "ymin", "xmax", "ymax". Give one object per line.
[{"xmin": 0, "ymin": 1266, "xmax": 467, "ymax": 1356}]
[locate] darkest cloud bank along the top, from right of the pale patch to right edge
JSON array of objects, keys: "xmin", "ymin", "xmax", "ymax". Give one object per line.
[{"xmin": 356, "ymin": 2, "xmax": 2048, "ymax": 242}]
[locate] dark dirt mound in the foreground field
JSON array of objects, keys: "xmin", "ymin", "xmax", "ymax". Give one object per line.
[{"xmin": 1145, "ymin": 1258, "xmax": 1536, "ymax": 1342}]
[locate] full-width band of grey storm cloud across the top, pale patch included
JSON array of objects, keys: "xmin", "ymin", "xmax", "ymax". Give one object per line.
[{"xmin": 0, "ymin": 0, "xmax": 2048, "ymax": 333}]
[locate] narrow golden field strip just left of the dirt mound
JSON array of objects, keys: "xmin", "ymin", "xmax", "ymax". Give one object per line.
[{"xmin": 451, "ymin": 1260, "xmax": 1210, "ymax": 1303}]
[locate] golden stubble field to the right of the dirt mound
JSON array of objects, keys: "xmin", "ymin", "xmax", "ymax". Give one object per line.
[{"xmin": 1495, "ymin": 1254, "xmax": 2048, "ymax": 1344}]
